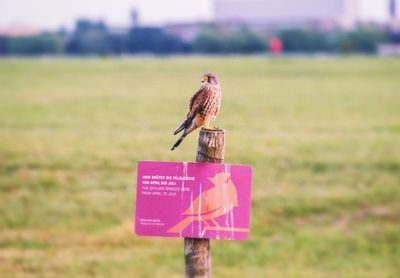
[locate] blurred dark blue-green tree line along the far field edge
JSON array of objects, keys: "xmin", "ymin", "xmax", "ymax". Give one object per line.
[{"xmin": 0, "ymin": 20, "xmax": 400, "ymax": 55}]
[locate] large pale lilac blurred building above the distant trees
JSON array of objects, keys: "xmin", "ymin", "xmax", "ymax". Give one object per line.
[{"xmin": 214, "ymin": 0, "xmax": 360, "ymax": 29}]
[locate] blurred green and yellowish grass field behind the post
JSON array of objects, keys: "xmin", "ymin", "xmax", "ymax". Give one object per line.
[{"xmin": 0, "ymin": 57, "xmax": 400, "ymax": 277}]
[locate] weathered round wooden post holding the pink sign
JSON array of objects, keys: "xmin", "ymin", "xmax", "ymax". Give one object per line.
[{"xmin": 185, "ymin": 129, "xmax": 225, "ymax": 278}]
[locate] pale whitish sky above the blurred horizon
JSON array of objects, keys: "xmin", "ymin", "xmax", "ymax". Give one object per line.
[{"xmin": 0, "ymin": 0, "xmax": 394, "ymax": 30}]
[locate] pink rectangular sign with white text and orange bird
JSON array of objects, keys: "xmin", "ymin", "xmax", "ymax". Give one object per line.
[{"xmin": 135, "ymin": 161, "xmax": 252, "ymax": 240}]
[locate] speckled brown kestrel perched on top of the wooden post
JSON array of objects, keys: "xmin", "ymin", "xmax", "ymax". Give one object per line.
[{"xmin": 171, "ymin": 72, "xmax": 222, "ymax": 151}]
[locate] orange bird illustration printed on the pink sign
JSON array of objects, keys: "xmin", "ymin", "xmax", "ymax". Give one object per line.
[{"xmin": 167, "ymin": 172, "xmax": 239, "ymax": 233}]
